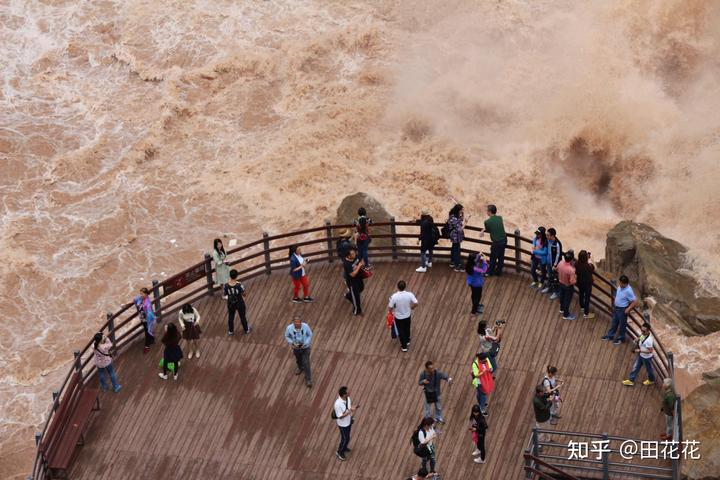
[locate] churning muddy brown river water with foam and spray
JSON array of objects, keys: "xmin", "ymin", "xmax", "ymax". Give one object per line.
[{"xmin": 0, "ymin": 0, "xmax": 720, "ymax": 478}]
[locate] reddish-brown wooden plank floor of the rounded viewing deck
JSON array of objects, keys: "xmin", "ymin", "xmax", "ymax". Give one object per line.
[{"xmin": 70, "ymin": 262, "xmax": 664, "ymax": 480}]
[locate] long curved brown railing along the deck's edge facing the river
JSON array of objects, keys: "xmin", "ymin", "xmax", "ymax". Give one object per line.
[{"xmin": 32, "ymin": 218, "xmax": 681, "ymax": 480}]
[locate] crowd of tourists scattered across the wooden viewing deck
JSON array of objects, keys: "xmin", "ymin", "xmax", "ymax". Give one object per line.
[{"xmin": 94, "ymin": 204, "xmax": 675, "ymax": 479}]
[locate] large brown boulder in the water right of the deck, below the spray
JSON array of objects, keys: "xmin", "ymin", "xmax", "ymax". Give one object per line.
[{"xmin": 603, "ymin": 221, "xmax": 720, "ymax": 335}]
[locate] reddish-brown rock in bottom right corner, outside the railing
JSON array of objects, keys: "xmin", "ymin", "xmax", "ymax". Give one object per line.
[{"xmin": 681, "ymin": 384, "xmax": 720, "ymax": 480}]
